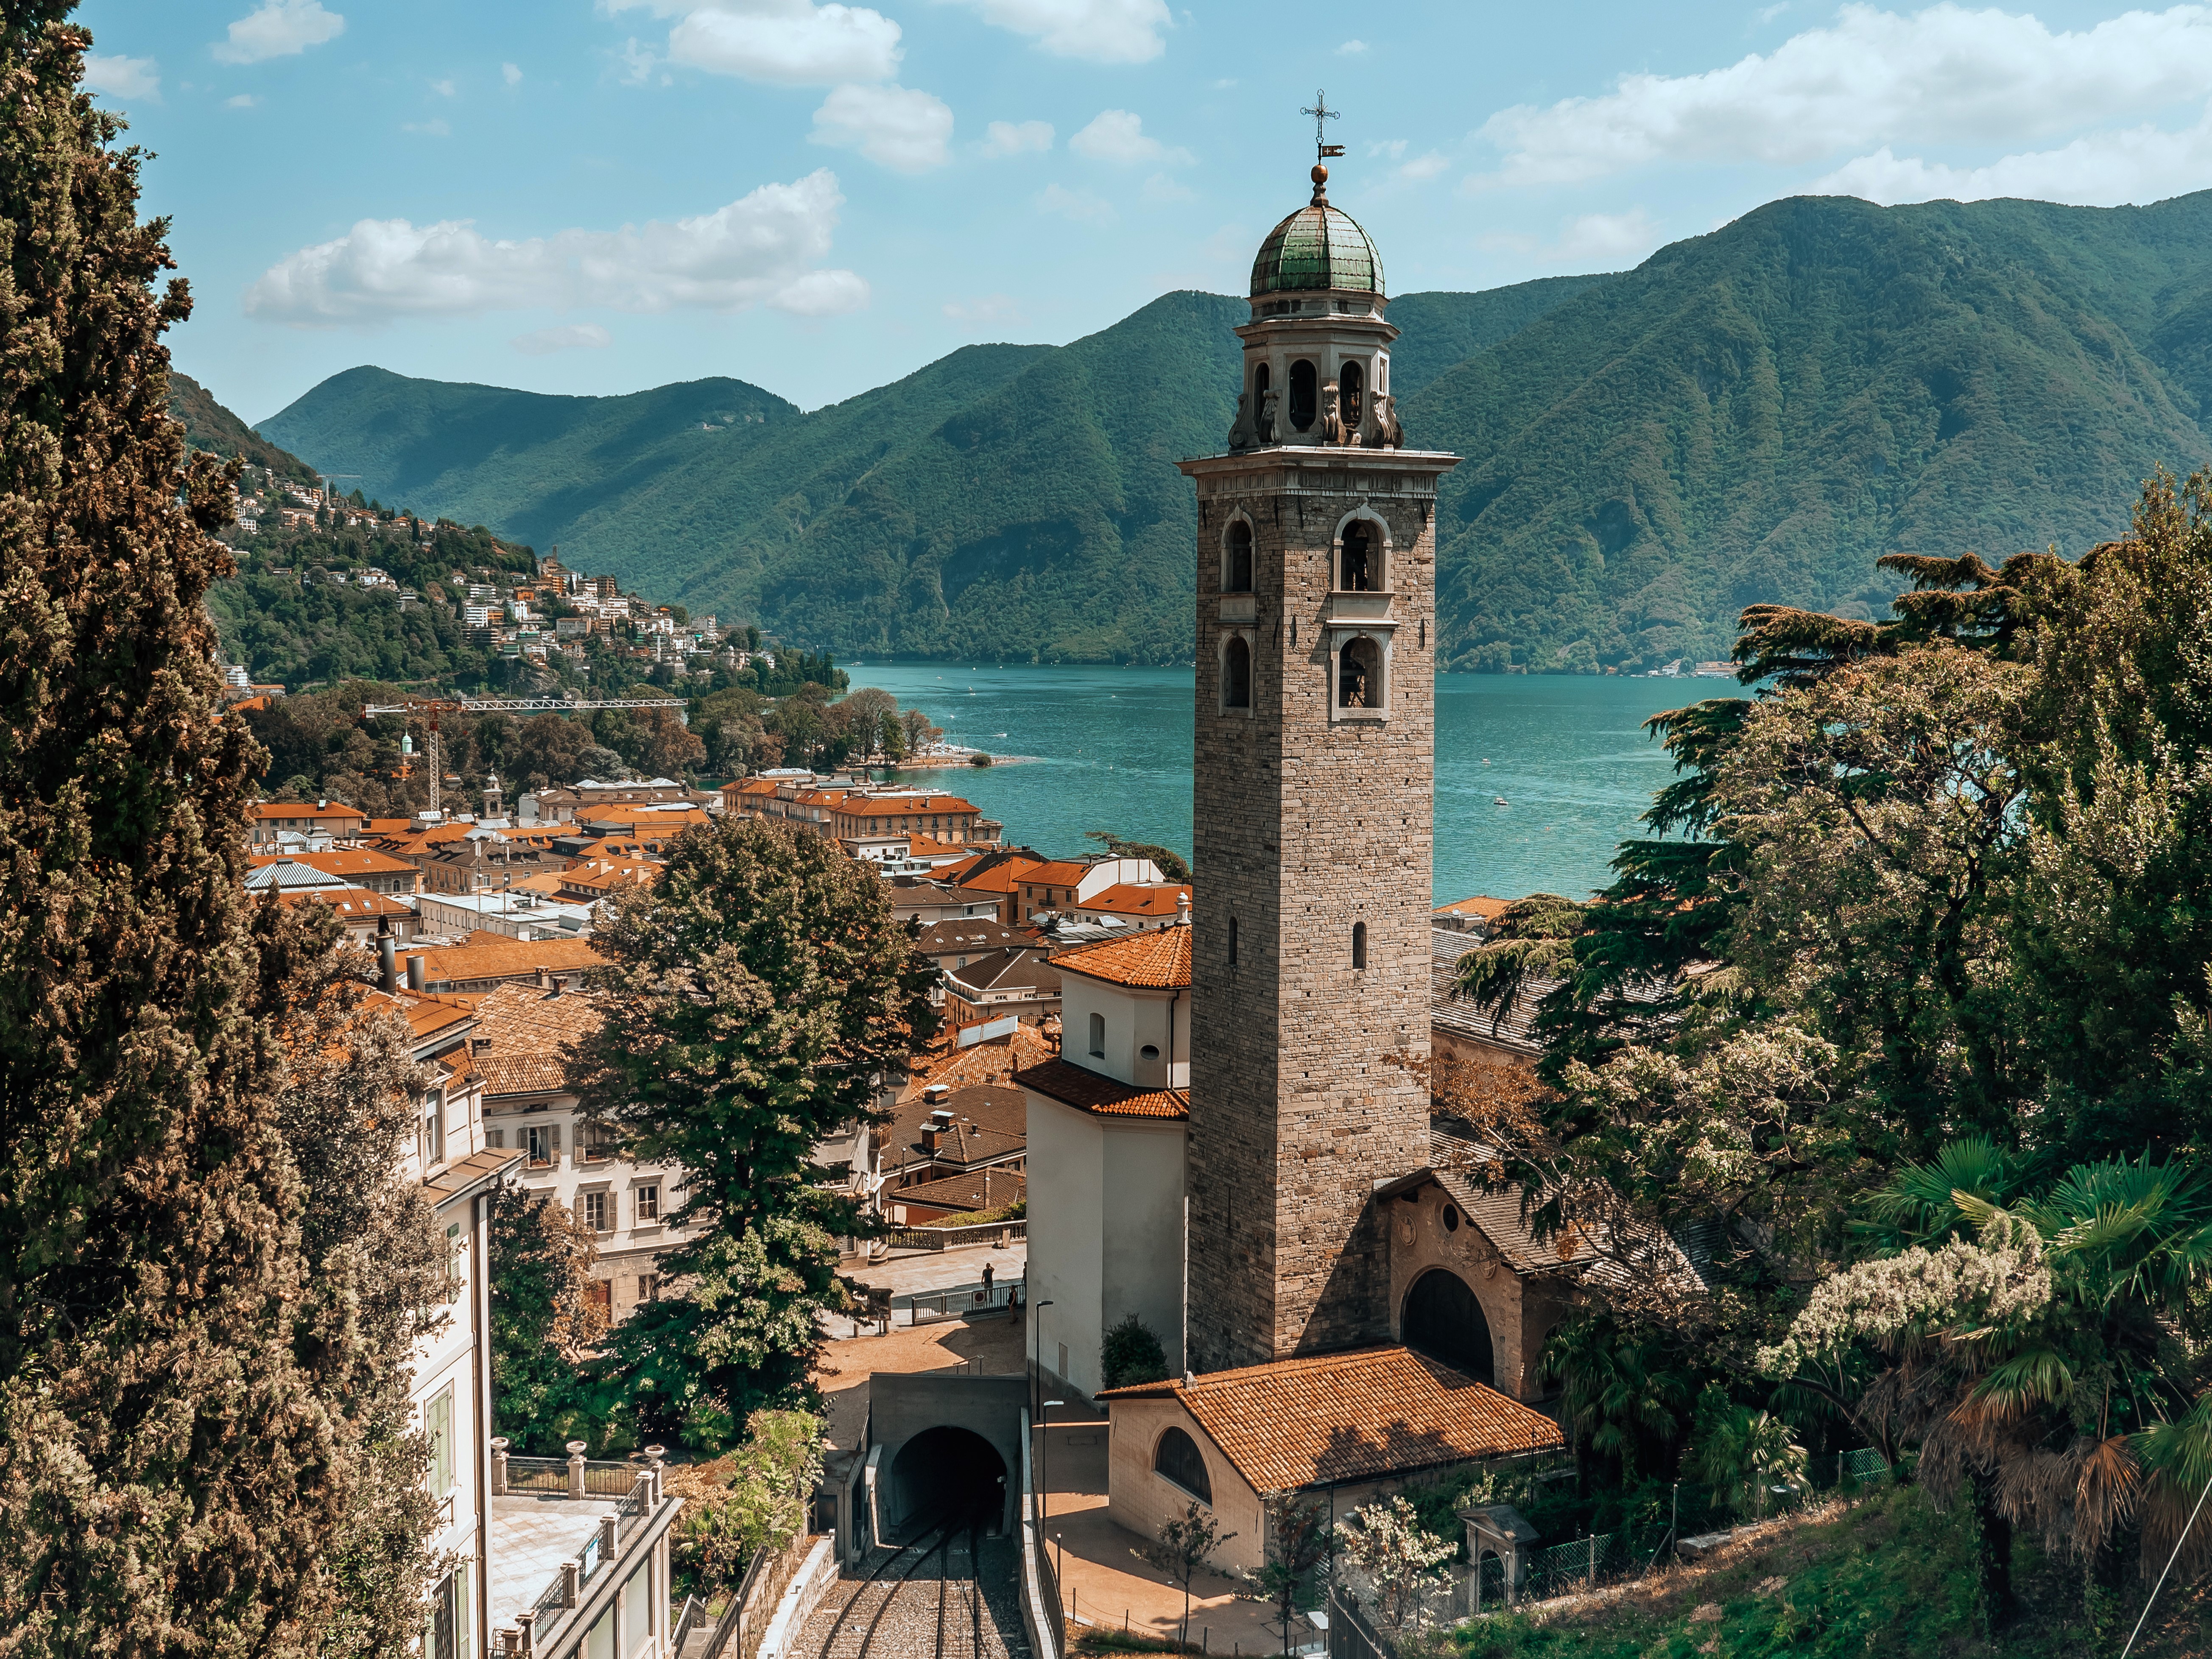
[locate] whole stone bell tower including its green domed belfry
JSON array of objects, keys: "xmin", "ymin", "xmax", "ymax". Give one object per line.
[{"xmin": 1181, "ymin": 156, "xmax": 1458, "ymax": 1369}]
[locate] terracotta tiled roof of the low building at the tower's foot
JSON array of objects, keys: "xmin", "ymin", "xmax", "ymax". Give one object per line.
[{"xmin": 1099, "ymin": 1347, "xmax": 1566, "ymax": 1491}]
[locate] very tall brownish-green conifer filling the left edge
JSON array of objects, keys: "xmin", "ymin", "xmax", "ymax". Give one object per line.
[{"xmin": 0, "ymin": 13, "xmax": 416, "ymax": 1655}]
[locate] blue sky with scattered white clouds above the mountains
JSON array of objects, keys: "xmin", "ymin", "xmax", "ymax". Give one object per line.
[{"xmin": 80, "ymin": 0, "xmax": 2212, "ymax": 420}]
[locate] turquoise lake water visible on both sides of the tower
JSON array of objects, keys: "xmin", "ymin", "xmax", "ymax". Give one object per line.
[{"xmin": 847, "ymin": 664, "xmax": 1707, "ymax": 905}]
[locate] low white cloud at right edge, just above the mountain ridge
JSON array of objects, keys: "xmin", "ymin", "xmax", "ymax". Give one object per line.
[{"xmin": 1812, "ymin": 109, "xmax": 2212, "ymax": 208}]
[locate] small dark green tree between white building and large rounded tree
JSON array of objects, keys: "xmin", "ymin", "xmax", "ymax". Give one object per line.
[{"xmin": 489, "ymin": 1186, "xmax": 608, "ymax": 1458}]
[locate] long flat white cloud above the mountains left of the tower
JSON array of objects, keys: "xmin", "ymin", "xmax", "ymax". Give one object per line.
[{"xmin": 246, "ymin": 168, "xmax": 867, "ymax": 325}]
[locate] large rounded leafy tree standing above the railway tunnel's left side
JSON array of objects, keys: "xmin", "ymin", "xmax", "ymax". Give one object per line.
[{"xmin": 582, "ymin": 818, "xmax": 933, "ymax": 1449}]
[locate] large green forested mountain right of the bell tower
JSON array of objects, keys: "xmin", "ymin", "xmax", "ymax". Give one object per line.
[{"xmin": 1402, "ymin": 193, "xmax": 2212, "ymax": 668}]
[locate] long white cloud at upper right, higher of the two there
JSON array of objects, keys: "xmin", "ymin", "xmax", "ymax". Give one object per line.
[{"xmin": 1480, "ymin": 2, "xmax": 2212, "ymax": 184}]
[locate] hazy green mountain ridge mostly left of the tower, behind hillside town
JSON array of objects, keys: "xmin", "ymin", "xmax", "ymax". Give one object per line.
[{"xmin": 261, "ymin": 279, "xmax": 1601, "ymax": 662}]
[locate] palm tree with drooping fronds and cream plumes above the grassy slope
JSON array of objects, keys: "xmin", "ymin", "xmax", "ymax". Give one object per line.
[{"xmin": 1761, "ymin": 1141, "xmax": 2212, "ymax": 1628}]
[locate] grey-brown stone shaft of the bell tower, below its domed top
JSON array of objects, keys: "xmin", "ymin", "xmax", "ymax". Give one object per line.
[{"xmin": 1184, "ymin": 449, "xmax": 1453, "ymax": 1369}]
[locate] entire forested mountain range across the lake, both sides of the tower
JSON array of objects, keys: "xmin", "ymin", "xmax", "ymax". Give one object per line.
[{"xmin": 246, "ymin": 193, "xmax": 2212, "ymax": 670}]
